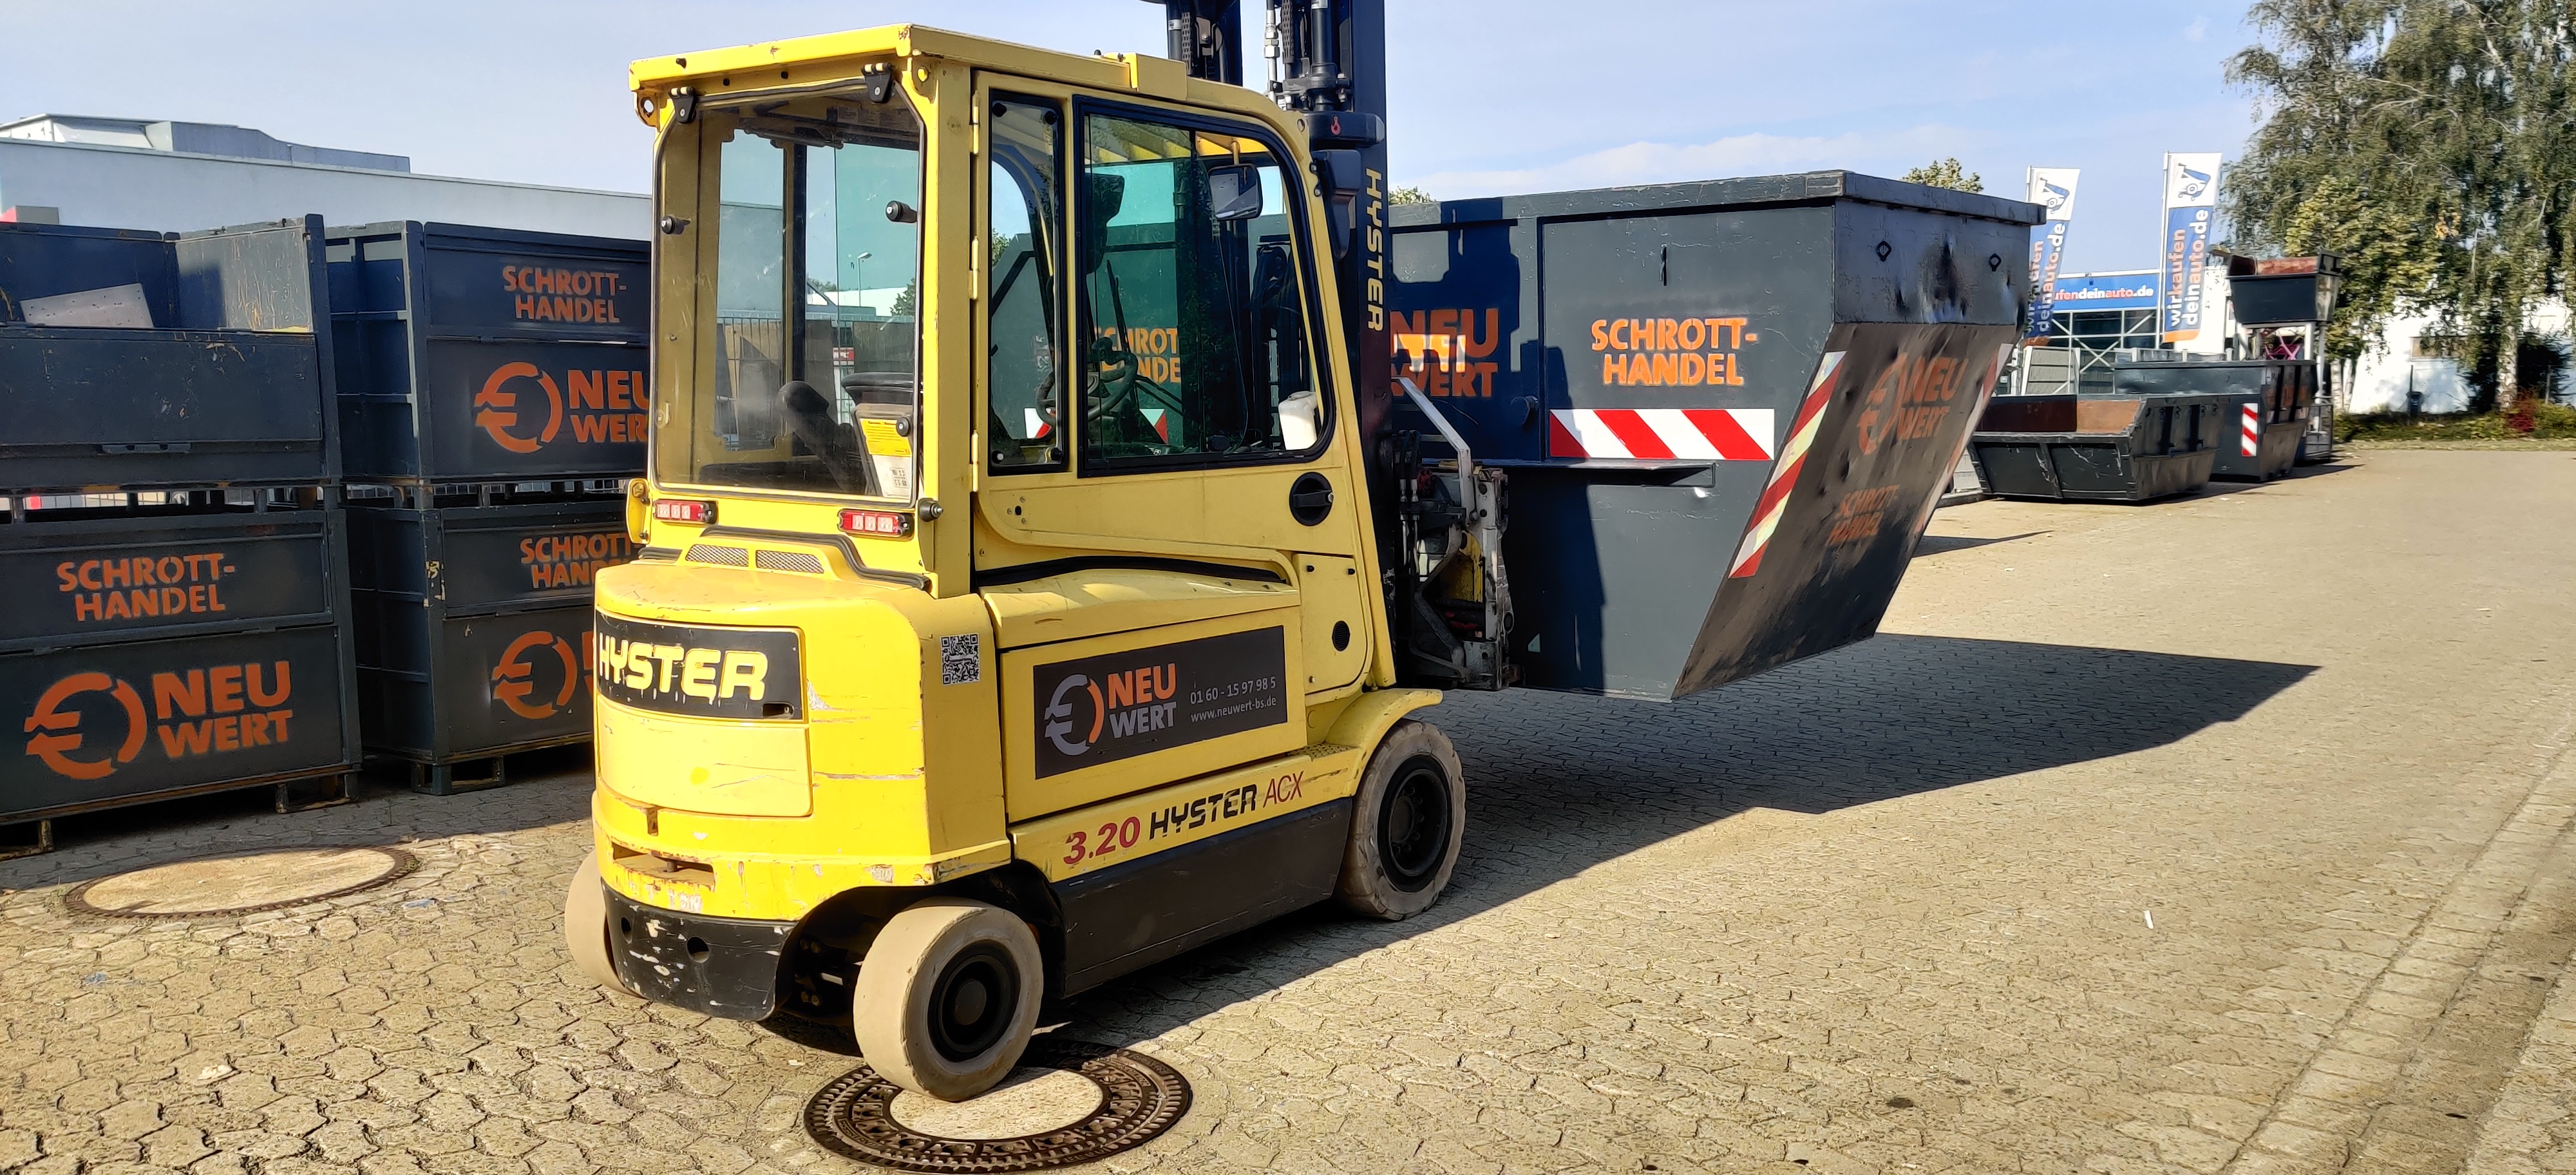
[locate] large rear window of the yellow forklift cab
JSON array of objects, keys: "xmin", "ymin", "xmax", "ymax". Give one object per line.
[{"xmin": 659, "ymin": 88, "xmax": 922, "ymax": 502}]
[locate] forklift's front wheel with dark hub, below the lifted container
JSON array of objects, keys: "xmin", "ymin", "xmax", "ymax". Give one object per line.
[{"xmin": 1334, "ymin": 719, "xmax": 1466, "ymax": 922}]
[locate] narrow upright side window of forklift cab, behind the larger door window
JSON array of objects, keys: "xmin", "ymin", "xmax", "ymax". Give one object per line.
[{"xmin": 984, "ymin": 95, "xmax": 1066, "ymax": 472}]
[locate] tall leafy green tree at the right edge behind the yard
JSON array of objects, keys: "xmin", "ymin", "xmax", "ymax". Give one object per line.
[{"xmin": 2228, "ymin": 0, "xmax": 2576, "ymax": 407}]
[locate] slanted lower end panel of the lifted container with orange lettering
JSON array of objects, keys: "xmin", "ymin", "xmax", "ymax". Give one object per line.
[{"xmin": 1677, "ymin": 322, "xmax": 2012, "ymax": 693}]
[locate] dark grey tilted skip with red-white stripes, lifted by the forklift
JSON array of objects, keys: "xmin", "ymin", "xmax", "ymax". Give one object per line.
[{"xmin": 1401, "ymin": 173, "xmax": 2040, "ymax": 698}]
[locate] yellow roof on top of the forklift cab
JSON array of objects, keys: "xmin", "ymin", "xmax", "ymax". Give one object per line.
[{"xmin": 626, "ymin": 23, "xmax": 1291, "ymax": 134}]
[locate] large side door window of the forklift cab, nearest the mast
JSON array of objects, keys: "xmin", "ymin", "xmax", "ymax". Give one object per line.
[{"xmin": 1074, "ymin": 111, "xmax": 1327, "ymax": 474}]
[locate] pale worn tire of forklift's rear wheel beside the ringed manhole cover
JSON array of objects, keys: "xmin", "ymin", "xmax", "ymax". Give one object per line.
[{"xmin": 850, "ymin": 897, "xmax": 1046, "ymax": 1100}]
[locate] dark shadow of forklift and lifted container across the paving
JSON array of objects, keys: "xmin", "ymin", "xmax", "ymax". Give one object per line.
[{"xmin": 1061, "ymin": 636, "xmax": 2316, "ymax": 1044}]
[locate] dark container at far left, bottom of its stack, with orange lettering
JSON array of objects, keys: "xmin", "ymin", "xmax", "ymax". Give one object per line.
[{"xmin": 0, "ymin": 508, "xmax": 358, "ymax": 822}]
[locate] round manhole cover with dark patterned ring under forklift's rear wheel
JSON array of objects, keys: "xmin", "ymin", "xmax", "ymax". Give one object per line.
[{"xmin": 806, "ymin": 1036, "xmax": 1190, "ymax": 1172}]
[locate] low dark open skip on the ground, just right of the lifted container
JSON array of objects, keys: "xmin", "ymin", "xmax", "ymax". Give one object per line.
[{"xmin": 1971, "ymin": 394, "xmax": 2233, "ymax": 502}]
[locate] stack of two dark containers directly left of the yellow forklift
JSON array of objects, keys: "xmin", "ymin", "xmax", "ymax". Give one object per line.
[{"xmin": 330, "ymin": 222, "xmax": 652, "ymax": 794}]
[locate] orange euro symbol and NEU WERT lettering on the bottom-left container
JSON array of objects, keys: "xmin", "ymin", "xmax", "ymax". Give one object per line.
[{"xmin": 26, "ymin": 662, "xmax": 296, "ymax": 778}]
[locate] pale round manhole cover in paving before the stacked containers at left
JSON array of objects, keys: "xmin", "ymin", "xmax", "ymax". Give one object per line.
[{"xmin": 62, "ymin": 845, "xmax": 420, "ymax": 917}]
